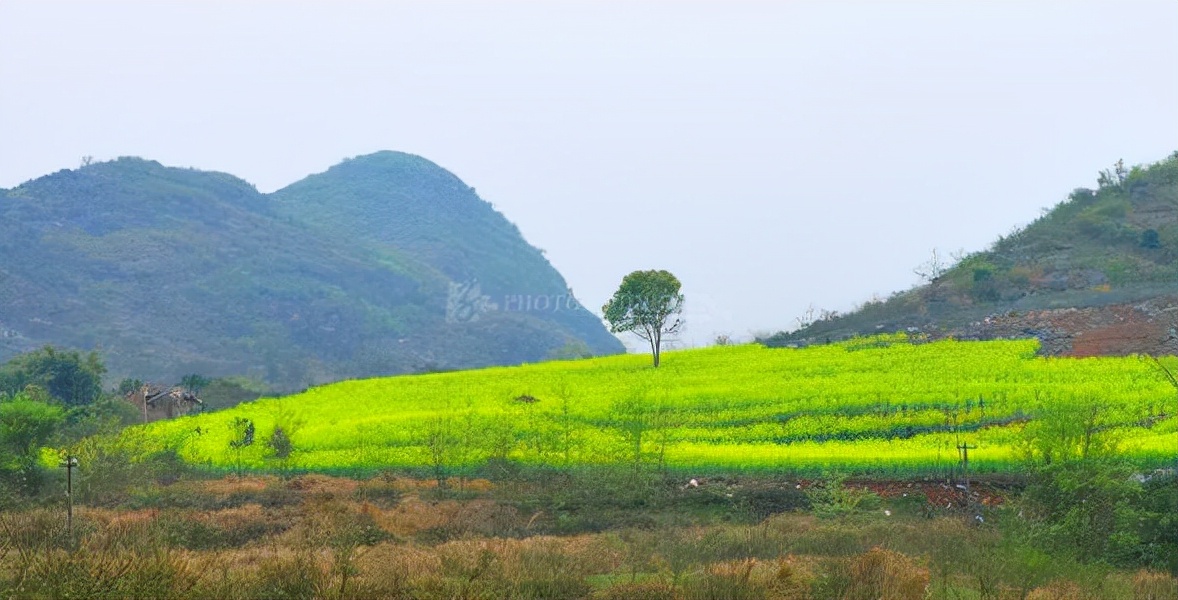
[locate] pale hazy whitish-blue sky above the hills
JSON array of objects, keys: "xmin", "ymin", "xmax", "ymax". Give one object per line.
[{"xmin": 0, "ymin": 0, "xmax": 1178, "ymax": 348}]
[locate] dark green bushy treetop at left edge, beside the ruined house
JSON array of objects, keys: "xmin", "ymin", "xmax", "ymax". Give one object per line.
[{"xmin": 0, "ymin": 345, "xmax": 106, "ymax": 406}]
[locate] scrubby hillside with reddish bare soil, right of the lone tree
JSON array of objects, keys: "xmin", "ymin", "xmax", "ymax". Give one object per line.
[{"xmin": 763, "ymin": 152, "xmax": 1178, "ymax": 355}]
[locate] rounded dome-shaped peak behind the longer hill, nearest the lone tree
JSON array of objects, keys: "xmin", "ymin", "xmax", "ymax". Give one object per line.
[{"xmin": 273, "ymin": 152, "xmax": 621, "ymax": 351}]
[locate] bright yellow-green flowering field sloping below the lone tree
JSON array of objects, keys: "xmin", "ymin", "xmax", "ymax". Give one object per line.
[{"xmin": 124, "ymin": 335, "xmax": 1178, "ymax": 475}]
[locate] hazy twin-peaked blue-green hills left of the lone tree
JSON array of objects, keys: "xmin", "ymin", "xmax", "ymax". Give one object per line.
[{"xmin": 0, "ymin": 152, "xmax": 623, "ymax": 389}]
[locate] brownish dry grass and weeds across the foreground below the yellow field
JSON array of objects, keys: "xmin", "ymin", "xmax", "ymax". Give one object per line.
[{"xmin": 0, "ymin": 475, "xmax": 1178, "ymax": 600}]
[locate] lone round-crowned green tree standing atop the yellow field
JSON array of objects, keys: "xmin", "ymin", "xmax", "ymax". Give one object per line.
[{"xmin": 602, "ymin": 271, "xmax": 683, "ymax": 367}]
